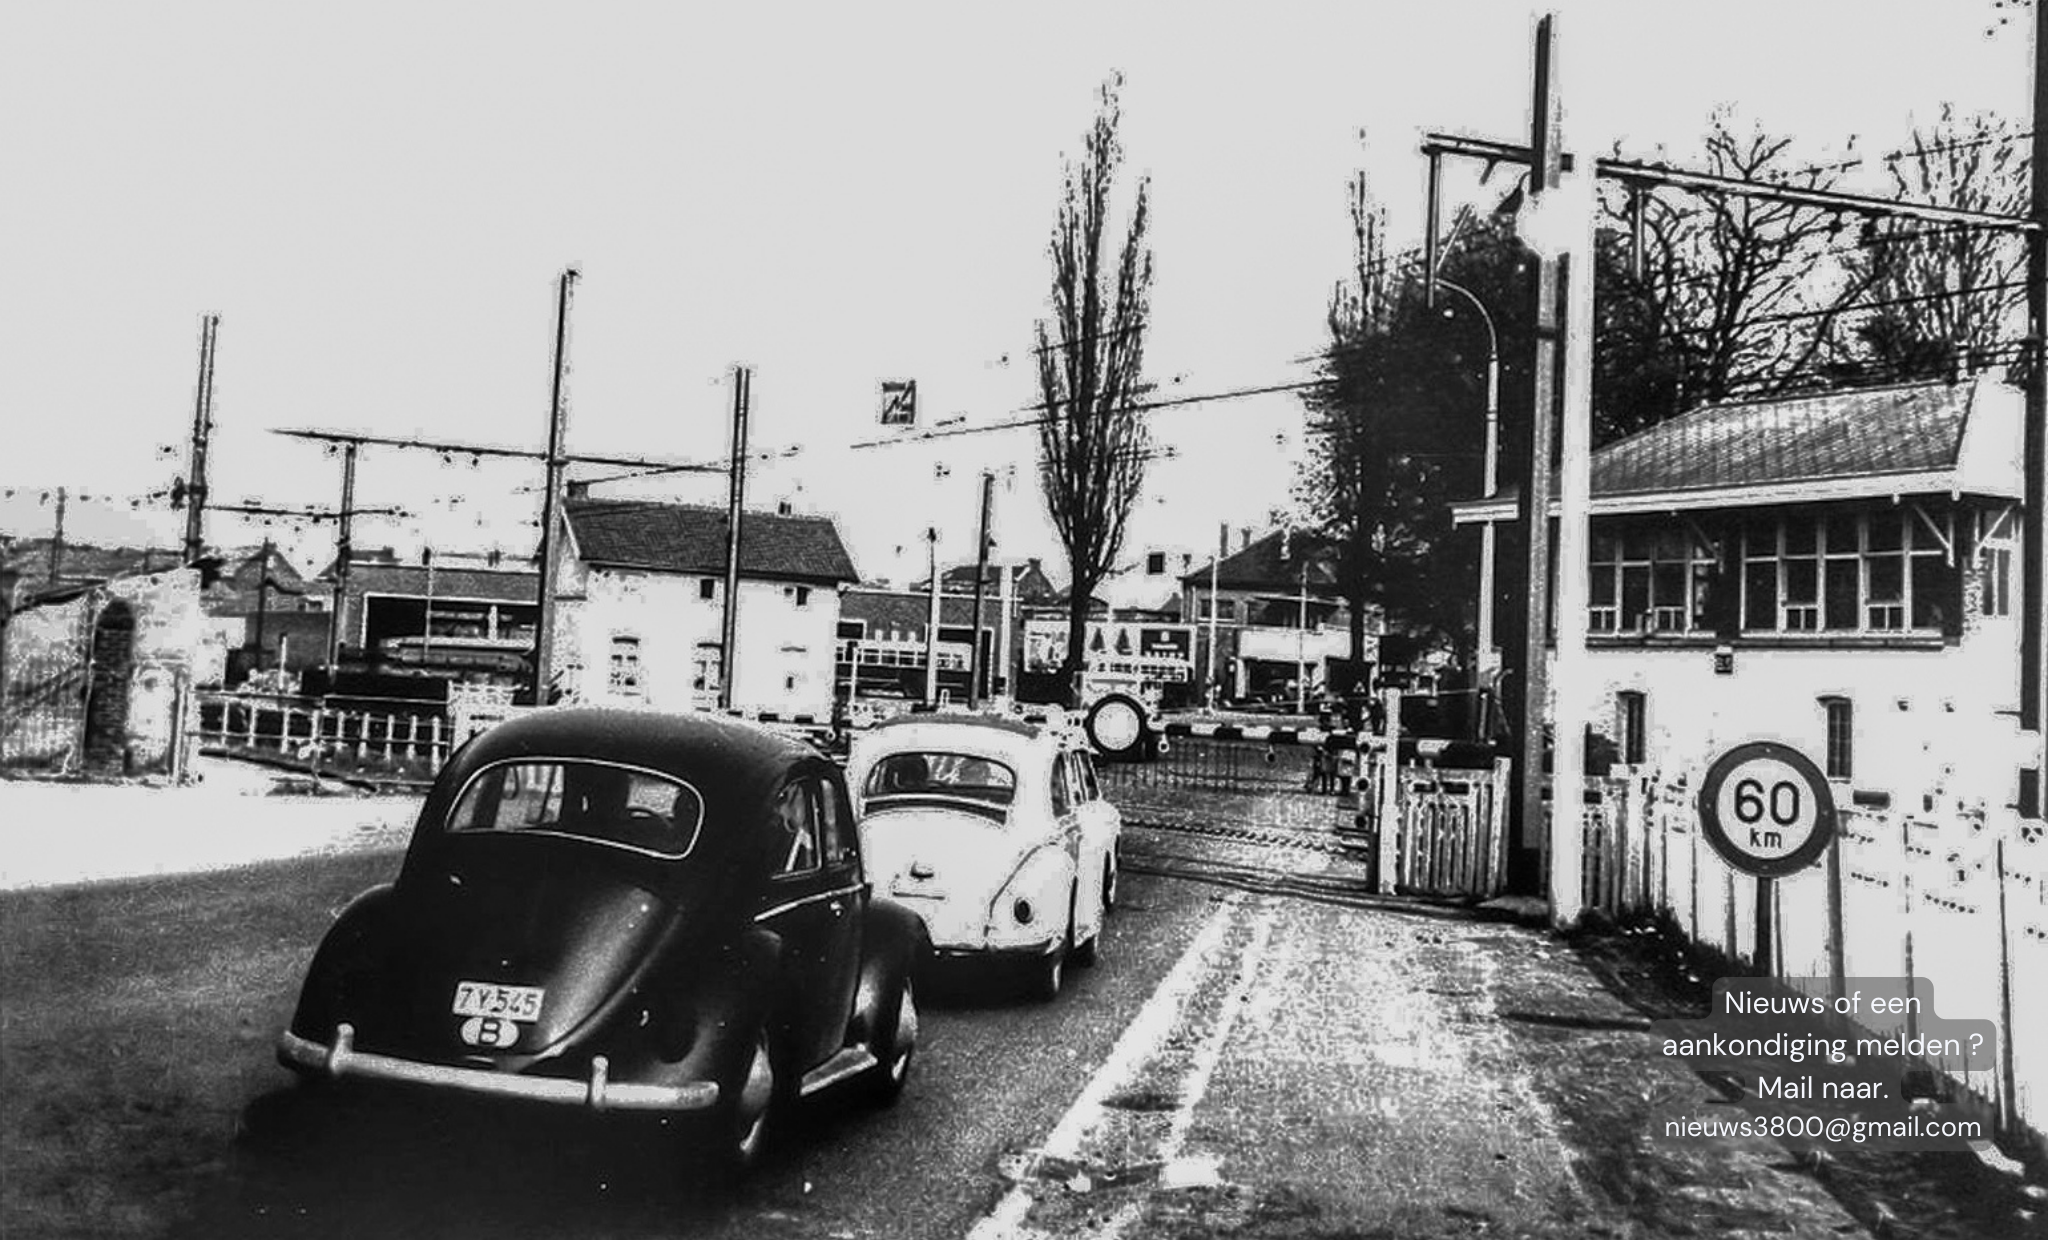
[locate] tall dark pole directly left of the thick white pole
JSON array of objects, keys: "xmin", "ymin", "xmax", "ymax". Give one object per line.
[{"xmin": 1509, "ymin": 14, "xmax": 1565, "ymax": 892}]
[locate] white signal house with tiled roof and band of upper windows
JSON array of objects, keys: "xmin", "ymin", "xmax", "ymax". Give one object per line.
[{"xmin": 1452, "ymin": 379, "xmax": 2021, "ymax": 812}]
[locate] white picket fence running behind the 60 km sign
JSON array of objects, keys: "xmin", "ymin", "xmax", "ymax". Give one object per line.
[{"xmin": 1583, "ymin": 777, "xmax": 2048, "ymax": 1152}]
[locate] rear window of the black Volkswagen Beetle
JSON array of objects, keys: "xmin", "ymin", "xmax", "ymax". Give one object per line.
[{"xmin": 449, "ymin": 760, "xmax": 705, "ymax": 857}]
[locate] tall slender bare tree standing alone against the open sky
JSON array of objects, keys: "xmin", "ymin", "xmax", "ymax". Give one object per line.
[{"xmin": 1036, "ymin": 78, "xmax": 1153, "ymax": 705}]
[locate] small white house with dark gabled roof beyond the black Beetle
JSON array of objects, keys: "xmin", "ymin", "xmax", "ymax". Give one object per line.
[{"xmin": 551, "ymin": 498, "xmax": 858, "ymax": 721}]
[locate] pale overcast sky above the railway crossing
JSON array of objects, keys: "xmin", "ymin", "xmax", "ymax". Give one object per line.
[{"xmin": 0, "ymin": 0, "xmax": 2032, "ymax": 578}]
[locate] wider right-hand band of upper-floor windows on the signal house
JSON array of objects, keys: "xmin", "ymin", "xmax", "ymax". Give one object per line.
[{"xmin": 1743, "ymin": 510, "xmax": 1950, "ymax": 633}]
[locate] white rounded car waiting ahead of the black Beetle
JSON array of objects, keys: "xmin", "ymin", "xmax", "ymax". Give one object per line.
[{"xmin": 846, "ymin": 711, "xmax": 1122, "ymax": 998}]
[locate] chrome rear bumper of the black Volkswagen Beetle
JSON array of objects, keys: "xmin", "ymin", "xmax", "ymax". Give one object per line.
[{"xmin": 276, "ymin": 1025, "xmax": 719, "ymax": 1111}]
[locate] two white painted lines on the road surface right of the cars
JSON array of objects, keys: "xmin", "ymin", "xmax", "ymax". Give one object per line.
[{"xmin": 967, "ymin": 892, "xmax": 1276, "ymax": 1240}]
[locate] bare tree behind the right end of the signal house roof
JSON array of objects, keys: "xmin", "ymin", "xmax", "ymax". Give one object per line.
[{"xmin": 1849, "ymin": 107, "xmax": 2028, "ymax": 379}]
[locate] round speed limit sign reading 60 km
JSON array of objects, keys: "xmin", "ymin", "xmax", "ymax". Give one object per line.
[{"xmin": 1700, "ymin": 740, "xmax": 1835, "ymax": 879}]
